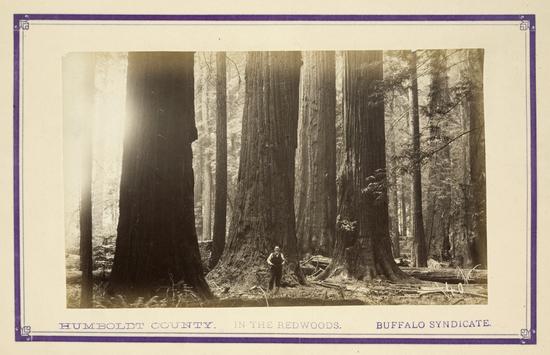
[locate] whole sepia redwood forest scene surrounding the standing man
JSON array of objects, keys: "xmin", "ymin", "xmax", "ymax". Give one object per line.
[{"xmin": 66, "ymin": 49, "xmax": 488, "ymax": 308}]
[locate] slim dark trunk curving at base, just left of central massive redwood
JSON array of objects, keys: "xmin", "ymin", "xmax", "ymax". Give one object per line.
[{"xmin": 210, "ymin": 52, "xmax": 227, "ymax": 268}]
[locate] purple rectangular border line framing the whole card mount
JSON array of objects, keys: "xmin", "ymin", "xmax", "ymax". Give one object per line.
[{"xmin": 13, "ymin": 14, "xmax": 537, "ymax": 344}]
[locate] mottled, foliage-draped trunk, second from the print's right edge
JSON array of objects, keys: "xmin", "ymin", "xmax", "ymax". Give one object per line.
[{"xmin": 424, "ymin": 50, "xmax": 452, "ymax": 260}]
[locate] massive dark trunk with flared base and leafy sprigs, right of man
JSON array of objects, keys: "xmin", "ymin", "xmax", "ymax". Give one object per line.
[{"xmin": 320, "ymin": 51, "xmax": 406, "ymax": 280}]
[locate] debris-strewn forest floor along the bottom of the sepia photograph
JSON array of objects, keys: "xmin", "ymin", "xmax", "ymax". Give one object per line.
[{"xmin": 67, "ymin": 264, "xmax": 488, "ymax": 308}]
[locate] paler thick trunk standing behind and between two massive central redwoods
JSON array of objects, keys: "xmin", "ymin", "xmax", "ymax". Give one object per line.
[{"xmin": 295, "ymin": 52, "xmax": 336, "ymax": 255}]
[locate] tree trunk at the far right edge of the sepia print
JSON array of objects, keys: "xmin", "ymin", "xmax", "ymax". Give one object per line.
[{"xmin": 467, "ymin": 49, "xmax": 487, "ymax": 268}]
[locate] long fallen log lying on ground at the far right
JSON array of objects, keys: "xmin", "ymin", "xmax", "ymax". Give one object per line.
[{"xmin": 401, "ymin": 267, "xmax": 487, "ymax": 284}]
